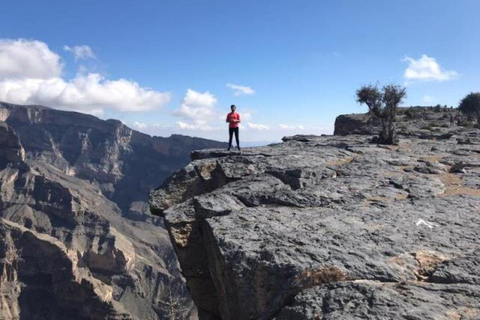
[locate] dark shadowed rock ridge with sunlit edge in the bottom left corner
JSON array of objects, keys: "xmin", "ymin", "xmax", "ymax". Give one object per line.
[{"xmin": 0, "ymin": 219, "xmax": 125, "ymax": 320}]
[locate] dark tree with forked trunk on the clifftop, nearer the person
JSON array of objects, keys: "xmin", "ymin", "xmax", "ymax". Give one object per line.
[{"xmin": 356, "ymin": 84, "xmax": 407, "ymax": 144}]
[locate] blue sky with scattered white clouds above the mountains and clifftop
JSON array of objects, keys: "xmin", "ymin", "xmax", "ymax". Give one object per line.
[{"xmin": 0, "ymin": 0, "xmax": 480, "ymax": 142}]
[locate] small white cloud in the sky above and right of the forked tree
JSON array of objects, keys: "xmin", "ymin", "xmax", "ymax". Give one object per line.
[{"xmin": 403, "ymin": 54, "xmax": 458, "ymax": 81}]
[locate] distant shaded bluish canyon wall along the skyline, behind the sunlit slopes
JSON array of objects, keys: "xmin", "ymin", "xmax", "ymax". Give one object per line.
[{"xmin": 0, "ymin": 103, "xmax": 227, "ymax": 219}]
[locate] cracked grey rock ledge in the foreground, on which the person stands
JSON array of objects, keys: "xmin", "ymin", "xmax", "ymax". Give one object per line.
[{"xmin": 150, "ymin": 127, "xmax": 480, "ymax": 320}]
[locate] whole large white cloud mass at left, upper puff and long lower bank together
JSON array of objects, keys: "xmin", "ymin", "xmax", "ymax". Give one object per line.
[{"xmin": 0, "ymin": 39, "xmax": 170, "ymax": 115}]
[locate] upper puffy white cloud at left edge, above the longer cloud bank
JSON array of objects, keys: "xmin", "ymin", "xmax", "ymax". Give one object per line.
[{"xmin": 0, "ymin": 39, "xmax": 63, "ymax": 80}]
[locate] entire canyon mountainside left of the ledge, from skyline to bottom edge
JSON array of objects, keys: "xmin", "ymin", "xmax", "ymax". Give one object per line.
[{"xmin": 0, "ymin": 103, "xmax": 224, "ymax": 320}]
